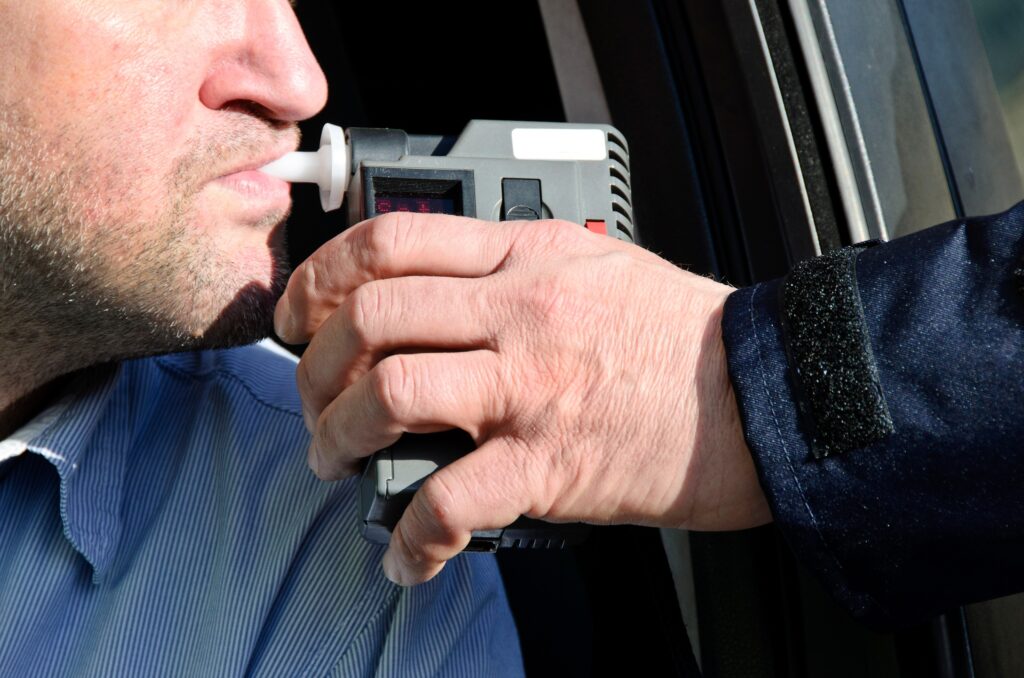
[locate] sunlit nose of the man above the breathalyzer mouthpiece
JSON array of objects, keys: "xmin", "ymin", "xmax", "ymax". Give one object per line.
[{"xmin": 200, "ymin": 0, "xmax": 327, "ymax": 122}]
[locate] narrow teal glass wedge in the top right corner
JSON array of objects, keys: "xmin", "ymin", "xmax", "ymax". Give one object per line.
[{"xmin": 971, "ymin": 0, "xmax": 1024, "ymax": 178}]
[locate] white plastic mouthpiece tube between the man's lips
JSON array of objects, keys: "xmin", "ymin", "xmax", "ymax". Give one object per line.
[{"xmin": 260, "ymin": 125, "xmax": 349, "ymax": 212}]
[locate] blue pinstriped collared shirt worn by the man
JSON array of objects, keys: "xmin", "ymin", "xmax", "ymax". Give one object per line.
[{"xmin": 0, "ymin": 344, "xmax": 522, "ymax": 676}]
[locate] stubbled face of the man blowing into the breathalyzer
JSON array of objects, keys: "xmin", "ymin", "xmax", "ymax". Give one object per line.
[{"xmin": 0, "ymin": 0, "xmax": 327, "ymax": 359}]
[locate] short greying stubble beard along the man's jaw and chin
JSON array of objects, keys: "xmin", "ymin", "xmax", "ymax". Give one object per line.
[{"xmin": 0, "ymin": 104, "xmax": 289, "ymax": 399}]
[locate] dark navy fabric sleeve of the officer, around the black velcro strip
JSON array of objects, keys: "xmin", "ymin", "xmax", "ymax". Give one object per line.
[{"xmin": 723, "ymin": 203, "xmax": 1024, "ymax": 627}]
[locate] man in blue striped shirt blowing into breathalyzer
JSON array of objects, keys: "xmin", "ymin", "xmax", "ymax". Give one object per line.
[{"xmin": 0, "ymin": 0, "xmax": 521, "ymax": 676}]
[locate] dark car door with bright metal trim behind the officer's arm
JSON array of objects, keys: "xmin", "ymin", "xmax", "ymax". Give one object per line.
[{"xmin": 565, "ymin": 0, "xmax": 1024, "ymax": 676}]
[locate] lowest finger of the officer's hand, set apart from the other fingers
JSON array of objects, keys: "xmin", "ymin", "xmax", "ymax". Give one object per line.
[{"xmin": 382, "ymin": 437, "xmax": 531, "ymax": 586}]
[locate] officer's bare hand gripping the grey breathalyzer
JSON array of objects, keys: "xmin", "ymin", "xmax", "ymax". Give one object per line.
[{"xmin": 274, "ymin": 213, "xmax": 770, "ymax": 585}]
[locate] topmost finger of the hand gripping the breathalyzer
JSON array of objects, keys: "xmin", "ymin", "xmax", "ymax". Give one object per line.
[{"xmin": 274, "ymin": 212, "xmax": 513, "ymax": 344}]
